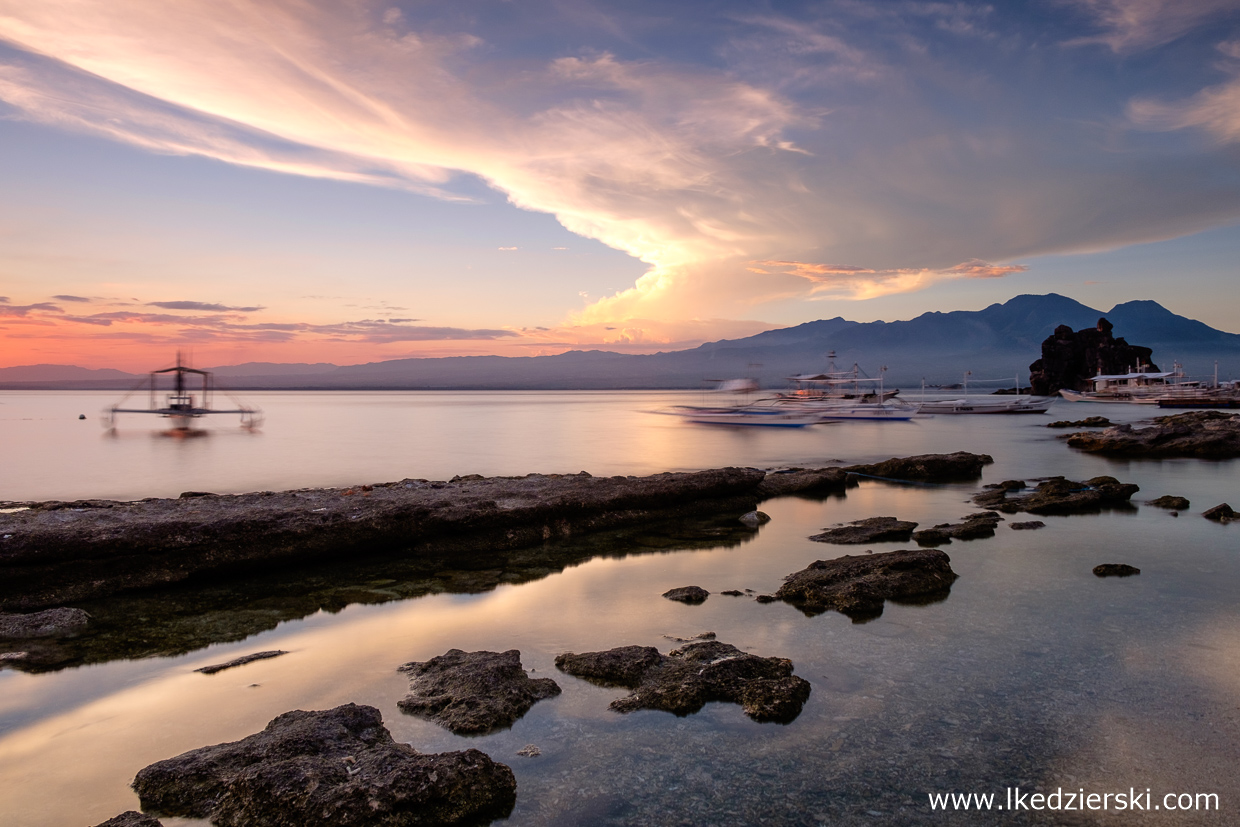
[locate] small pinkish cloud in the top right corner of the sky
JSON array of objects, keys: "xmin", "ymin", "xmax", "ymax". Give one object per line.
[{"xmin": 1065, "ymin": 0, "xmax": 1236, "ymax": 52}]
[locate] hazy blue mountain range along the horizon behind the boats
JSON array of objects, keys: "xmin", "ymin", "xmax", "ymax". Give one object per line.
[{"xmin": 7, "ymin": 293, "xmax": 1240, "ymax": 389}]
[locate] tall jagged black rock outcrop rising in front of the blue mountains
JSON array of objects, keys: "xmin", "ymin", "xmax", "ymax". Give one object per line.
[{"xmin": 1029, "ymin": 319, "xmax": 1158, "ymax": 397}]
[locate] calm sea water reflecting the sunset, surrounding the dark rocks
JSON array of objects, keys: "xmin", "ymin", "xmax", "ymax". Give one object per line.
[{"xmin": 0, "ymin": 393, "xmax": 1240, "ymax": 827}]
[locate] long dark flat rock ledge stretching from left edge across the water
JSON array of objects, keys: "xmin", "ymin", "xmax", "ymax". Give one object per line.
[{"xmin": 0, "ymin": 451, "xmax": 991, "ymax": 611}]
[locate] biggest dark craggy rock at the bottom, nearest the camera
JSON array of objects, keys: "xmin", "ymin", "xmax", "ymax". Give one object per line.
[{"xmin": 134, "ymin": 704, "xmax": 517, "ymax": 827}]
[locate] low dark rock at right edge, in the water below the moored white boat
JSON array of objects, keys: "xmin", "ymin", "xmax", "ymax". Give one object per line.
[{"xmin": 1068, "ymin": 410, "xmax": 1240, "ymax": 460}]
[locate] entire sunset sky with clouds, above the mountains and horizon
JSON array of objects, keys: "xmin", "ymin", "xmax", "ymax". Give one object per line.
[{"xmin": 0, "ymin": 0, "xmax": 1240, "ymax": 371}]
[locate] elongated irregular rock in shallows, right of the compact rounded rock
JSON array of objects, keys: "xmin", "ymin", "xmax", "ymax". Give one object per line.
[{"xmin": 556, "ymin": 641, "xmax": 810, "ymax": 723}]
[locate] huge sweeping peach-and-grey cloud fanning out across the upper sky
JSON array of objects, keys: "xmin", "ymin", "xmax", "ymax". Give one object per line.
[{"xmin": 0, "ymin": 0, "xmax": 1240, "ymax": 332}]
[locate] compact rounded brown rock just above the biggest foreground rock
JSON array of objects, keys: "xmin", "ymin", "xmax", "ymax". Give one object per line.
[{"xmin": 396, "ymin": 648, "xmax": 559, "ymax": 735}]
